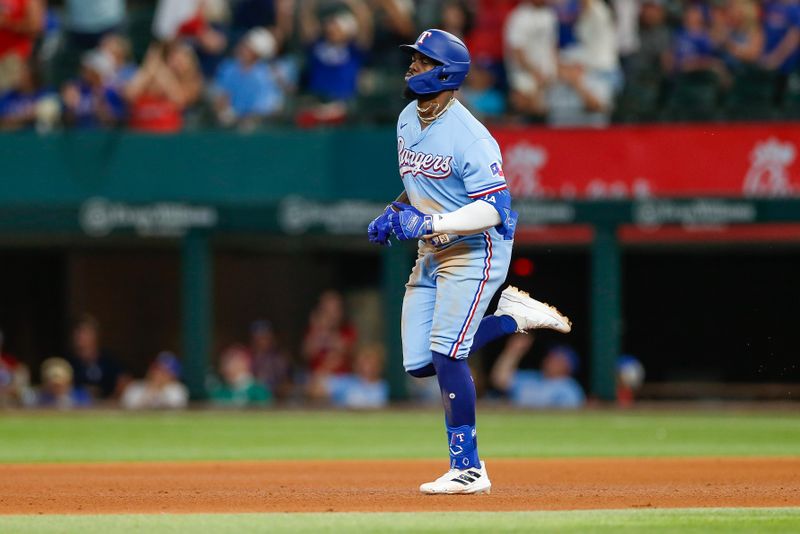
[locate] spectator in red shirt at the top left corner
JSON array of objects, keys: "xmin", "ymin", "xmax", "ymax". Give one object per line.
[{"xmin": 0, "ymin": 0, "xmax": 45, "ymax": 92}]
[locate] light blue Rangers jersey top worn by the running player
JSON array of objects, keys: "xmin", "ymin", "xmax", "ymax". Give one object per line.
[{"xmin": 397, "ymin": 101, "xmax": 507, "ymax": 244}]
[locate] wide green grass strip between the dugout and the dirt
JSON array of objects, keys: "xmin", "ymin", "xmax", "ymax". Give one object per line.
[{"xmin": 0, "ymin": 410, "xmax": 800, "ymax": 463}]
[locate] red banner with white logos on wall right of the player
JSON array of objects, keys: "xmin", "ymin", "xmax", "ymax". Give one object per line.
[{"xmin": 492, "ymin": 123, "xmax": 800, "ymax": 199}]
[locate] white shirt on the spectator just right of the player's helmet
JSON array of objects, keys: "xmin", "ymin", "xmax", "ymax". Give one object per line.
[{"xmin": 504, "ymin": 3, "xmax": 558, "ymax": 93}]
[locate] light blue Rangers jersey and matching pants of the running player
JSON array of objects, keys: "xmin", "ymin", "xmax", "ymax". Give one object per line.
[{"xmin": 397, "ymin": 101, "xmax": 513, "ymax": 371}]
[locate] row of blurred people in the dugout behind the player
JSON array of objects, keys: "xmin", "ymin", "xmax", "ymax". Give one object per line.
[{"xmin": 0, "ymin": 290, "xmax": 620, "ymax": 410}]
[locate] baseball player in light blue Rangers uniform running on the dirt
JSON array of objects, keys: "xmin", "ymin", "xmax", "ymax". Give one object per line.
[{"xmin": 368, "ymin": 29, "xmax": 571, "ymax": 494}]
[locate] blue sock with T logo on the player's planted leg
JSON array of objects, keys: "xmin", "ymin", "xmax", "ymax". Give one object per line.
[{"xmin": 433, "ymin": 352, "xmax": 481, "ymax": 469}]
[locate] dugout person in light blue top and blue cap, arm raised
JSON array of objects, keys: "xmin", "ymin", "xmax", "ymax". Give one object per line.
[{"xmin": 491, "ymin": 334, "xmax": 586, "ymax": 408}]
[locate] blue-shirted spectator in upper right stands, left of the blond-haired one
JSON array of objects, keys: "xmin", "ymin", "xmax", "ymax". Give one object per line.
[{"xmin": 668, "ymin": 4, "xmax": 716, "ymax": 72}]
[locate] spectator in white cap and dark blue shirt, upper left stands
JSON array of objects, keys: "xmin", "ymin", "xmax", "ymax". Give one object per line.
[{"xmin": 61, "ymin": 50, "xmax": 125, "ymax": 128}]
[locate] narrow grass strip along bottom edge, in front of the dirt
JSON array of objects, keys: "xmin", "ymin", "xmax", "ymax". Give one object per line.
[{"xmin": 0, "ymin": 508, "xmax": 800, "ymax": 534}]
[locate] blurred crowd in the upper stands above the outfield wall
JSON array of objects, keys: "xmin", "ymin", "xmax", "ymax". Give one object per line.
[{"xmin": 0, "ymin": 0, "xmax": 800, "ymax": 132}]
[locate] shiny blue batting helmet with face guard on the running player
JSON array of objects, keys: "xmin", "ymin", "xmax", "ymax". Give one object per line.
[{"xmin": 401, "ymin": 29, "xmax": 469, "ymax": 95}]
